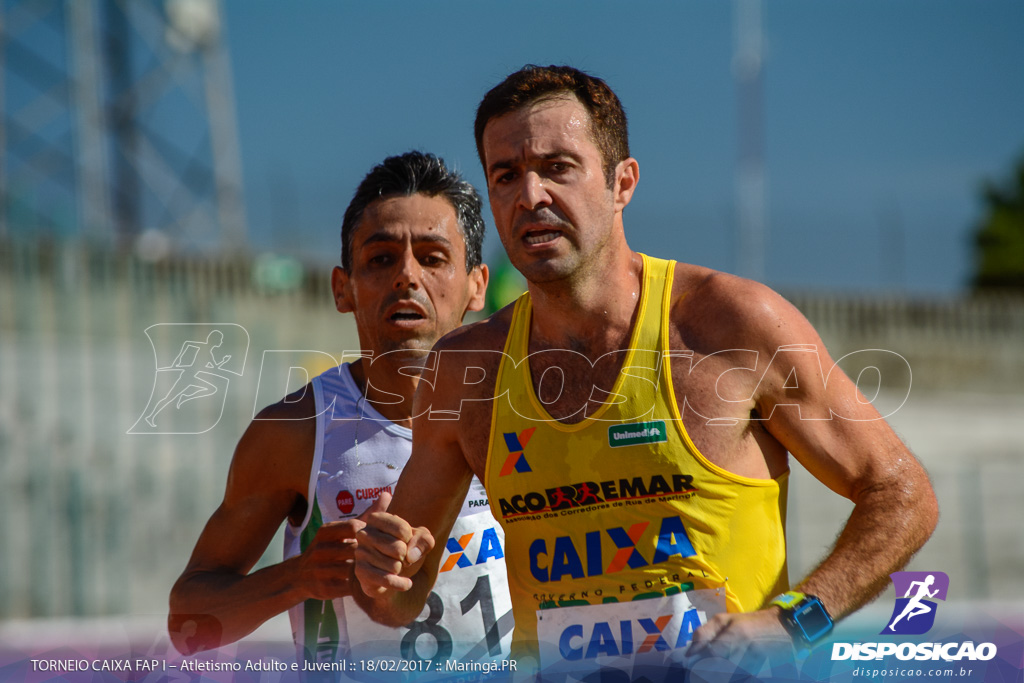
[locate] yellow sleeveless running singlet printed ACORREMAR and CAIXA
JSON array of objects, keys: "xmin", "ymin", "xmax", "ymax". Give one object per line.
[{"xmin": 484, "ymin": 256, "xmax": 788, "ymax": 651}]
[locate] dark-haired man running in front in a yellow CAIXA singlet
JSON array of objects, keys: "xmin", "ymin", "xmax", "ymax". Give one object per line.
[{"xmin": 356, "ymin": 67, "xmax": 937, "ymax": 663}]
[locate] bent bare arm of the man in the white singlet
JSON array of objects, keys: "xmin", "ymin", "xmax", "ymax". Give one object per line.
[{"xmin": 168, "ymin": 391, "xmax": 359, "ymax": 653}]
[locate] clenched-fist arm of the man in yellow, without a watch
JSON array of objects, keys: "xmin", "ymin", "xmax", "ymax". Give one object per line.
[{"xmin": 355, "ymin": 309, "xmax": 510, "ymax": 626}]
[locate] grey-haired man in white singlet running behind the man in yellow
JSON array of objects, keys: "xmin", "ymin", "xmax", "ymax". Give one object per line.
[{"xmin": 168, "ymin": 153, "xmax": 520, "ymax": 675}]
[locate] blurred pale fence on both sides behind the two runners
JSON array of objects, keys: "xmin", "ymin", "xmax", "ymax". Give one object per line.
[{"xmin": 0, "ymin": 242, "xmax": 1024, "ymax": 618}]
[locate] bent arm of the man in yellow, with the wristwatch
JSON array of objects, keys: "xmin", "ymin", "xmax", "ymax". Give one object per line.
[{"xmin": 695, "ymin": 279, "xmax": 938, "ymax": 645}]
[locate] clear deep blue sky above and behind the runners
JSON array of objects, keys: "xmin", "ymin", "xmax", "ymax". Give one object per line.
[{"xmin": 224, "ymin": 0, "xmax": 1024, "ymax": 294}]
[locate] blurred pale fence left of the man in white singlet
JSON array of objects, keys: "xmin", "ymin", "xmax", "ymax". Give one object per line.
[{"xmin": 0, "ymin": 243, "xmax": 357, "ymax": 617}]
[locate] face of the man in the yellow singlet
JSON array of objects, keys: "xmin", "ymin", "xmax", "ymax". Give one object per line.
[{"xmin": 483, "ymin": 96, "xmax": 615, "ymax": 283}]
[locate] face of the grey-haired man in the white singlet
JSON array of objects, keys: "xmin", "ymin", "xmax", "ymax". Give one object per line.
[{"xmin": 332, "ymin": 195, "xmax": 486, "ymax": 355}]
